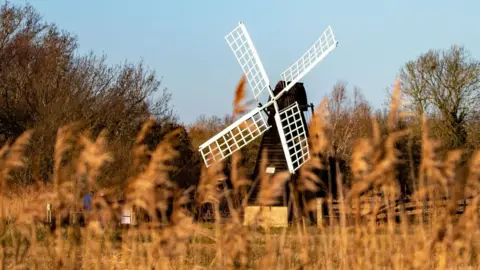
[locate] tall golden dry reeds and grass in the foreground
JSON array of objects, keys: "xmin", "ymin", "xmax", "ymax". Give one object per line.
[{"xmin": 0, "ymin": 77, "xmax": 480, "ymax": 269}]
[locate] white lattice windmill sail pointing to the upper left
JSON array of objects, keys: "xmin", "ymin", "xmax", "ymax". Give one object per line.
[{"xmin": 225, "ymin": 22, "xmax": 271, "ymax": 101}]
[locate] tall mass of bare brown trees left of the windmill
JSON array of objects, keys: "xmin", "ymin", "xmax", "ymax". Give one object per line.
[{"xmin": 0, "ymin": 2, "xmax": 176, "ymax": 186}]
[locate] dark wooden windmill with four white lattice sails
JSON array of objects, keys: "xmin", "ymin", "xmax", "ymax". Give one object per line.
[{"xmin": 199, "ymin": 22, "xmax": 338, "ymax": 202}]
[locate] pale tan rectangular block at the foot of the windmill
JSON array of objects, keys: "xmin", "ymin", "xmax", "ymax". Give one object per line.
[{"xmin": 243, "ymin": 206, "xmax": 288, "ymax": 227}]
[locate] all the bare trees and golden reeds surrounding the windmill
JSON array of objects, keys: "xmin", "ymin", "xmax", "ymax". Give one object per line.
[{"xmin": 0, "ymin": 3, "xmax": 480, "ymax": 269}]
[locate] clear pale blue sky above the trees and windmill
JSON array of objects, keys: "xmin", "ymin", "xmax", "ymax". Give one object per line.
[{"xmin": 18, "ymin": 0, "xmax": 480, "ymax": 123}]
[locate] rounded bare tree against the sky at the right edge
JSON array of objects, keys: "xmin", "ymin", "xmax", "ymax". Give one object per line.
[{"xmin": 400, "ymin": 45, "xmax": 480, "ymax": 148}]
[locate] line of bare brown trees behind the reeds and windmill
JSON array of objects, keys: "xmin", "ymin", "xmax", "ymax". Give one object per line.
[{"xmin": 0, "ymin": 3, "xmax": 480, "ymax": 200}]
